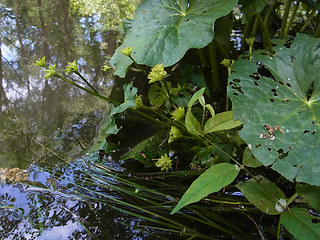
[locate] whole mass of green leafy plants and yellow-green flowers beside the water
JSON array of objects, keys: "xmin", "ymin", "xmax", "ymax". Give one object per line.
[{"xmin": 37, "ymin": 0, "xmax": 320, "ymax": 239}]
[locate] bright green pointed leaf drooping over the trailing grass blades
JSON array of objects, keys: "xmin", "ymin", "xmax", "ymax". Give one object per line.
[{"xmin": 171, "ymin": 163, "xmax": 240, "ymax": 214}]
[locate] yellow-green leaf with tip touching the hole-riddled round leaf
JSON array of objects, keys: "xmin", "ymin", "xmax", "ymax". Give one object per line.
[{"xmin": 204, "ymin": 111, "xmax": 242, "ymax": 133}]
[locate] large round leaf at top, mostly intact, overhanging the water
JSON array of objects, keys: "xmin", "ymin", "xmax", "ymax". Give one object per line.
[{"xmin": 110, "ymin": 0, "xmax": 238, "ymax": 77}]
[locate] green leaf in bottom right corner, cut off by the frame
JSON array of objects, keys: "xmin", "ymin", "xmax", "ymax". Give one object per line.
[{"xmin": 280, "ymin": 208, "xmax": 320, "ymax": 240}]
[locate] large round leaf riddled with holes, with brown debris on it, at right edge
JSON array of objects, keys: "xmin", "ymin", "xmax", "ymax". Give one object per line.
[{"xmin": 228, "ymin": 34, "xmax": 320, "ymax": 186}]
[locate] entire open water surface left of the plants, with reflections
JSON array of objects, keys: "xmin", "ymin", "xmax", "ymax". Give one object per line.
[{"xmin": 0, "ymin": 0, "xmax": 141, "ymax": 240}]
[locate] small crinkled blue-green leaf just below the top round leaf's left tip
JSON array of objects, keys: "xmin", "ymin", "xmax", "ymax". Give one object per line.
[{"xmin": 110, "ymin": 82, "xmax": 138, "ymax": 115}]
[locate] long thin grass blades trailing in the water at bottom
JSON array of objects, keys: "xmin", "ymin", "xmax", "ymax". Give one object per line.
[{"xmin": 28, "ymin": 158, "xmax": 248, "ymax": 239}]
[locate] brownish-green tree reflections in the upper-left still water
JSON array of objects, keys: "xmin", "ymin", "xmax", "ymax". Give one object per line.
[{"xmin": 0, "ymin": 0, "xmax": 124, "ymax": 168}]
